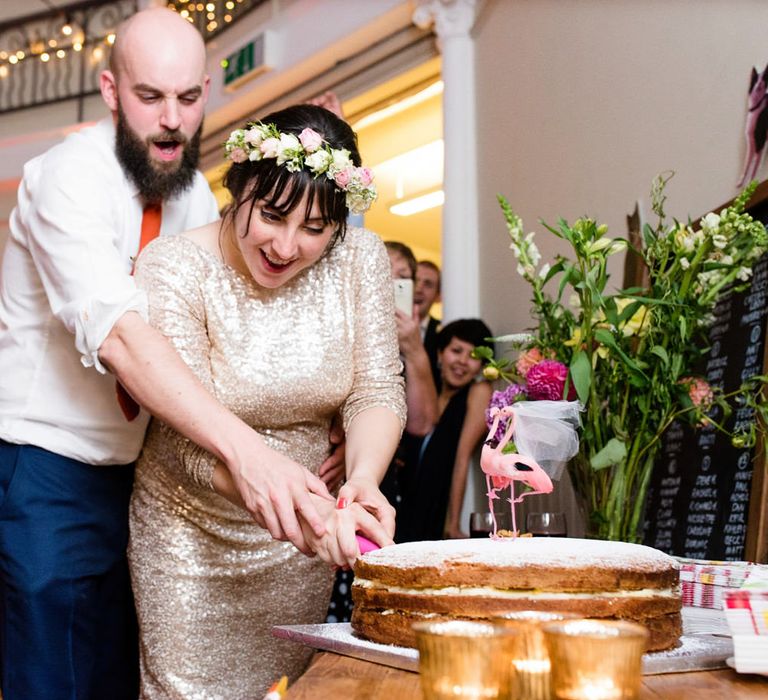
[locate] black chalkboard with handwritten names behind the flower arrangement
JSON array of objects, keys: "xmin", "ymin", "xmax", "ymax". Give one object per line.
[{"xmin": 645, "ymin": 183, "xmax": 768, "ymax": 562}]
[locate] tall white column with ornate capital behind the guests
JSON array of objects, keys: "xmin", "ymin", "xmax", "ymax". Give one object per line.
[{"xmin": 413, "ymin": 0, "xmax": 480, "ymax": 321}]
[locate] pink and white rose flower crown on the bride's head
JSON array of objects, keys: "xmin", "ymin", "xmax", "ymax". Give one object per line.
[{"xmin": 224, "ymin": 122, "xmax": 376, "ymax": 214}]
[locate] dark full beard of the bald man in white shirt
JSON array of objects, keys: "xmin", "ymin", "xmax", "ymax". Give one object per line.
[{"xmin": 116, "ymin": 105, "xmax": 203, "ymax": 203}]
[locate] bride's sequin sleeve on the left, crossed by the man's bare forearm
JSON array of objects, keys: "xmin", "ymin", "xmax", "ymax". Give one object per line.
[{"xmin": 135, "ymin": 236, "xmax": 216, "ymax": 488}]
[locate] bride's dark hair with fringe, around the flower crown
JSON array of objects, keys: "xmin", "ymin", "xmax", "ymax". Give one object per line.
[{"xmin": 223, "ymin": 104, "xmax": 361, "ymax": 242}]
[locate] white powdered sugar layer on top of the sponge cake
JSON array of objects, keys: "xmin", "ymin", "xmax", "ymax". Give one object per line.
[{"xmin": 363, "ymin": 537, "xmax": 677, "ymax": 572}]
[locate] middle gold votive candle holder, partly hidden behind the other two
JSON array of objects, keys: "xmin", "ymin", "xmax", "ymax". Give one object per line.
[{"xmin": 492, "ymin": 610, "xmax": 579, "ymax": 700}]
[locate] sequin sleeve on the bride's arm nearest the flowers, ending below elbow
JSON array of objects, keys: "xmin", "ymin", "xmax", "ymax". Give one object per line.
[{"xmin": 342, "ymin": 229, "xmax": 405, "ymax": 430}]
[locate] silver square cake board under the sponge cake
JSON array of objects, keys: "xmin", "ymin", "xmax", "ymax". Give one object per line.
[{"xmin": 272, "ymin": 622, "xmax": 733, "ymax": 676}]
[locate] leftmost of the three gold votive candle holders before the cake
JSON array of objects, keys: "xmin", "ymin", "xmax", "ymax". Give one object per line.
[{"xmin": 413, "ymin": 620, "xmax": 518, "ymax": 700}]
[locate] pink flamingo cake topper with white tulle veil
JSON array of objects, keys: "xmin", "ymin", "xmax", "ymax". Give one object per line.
[{"xmin": 480, "ymin": 401, "xmax": 580, "ymax": 537}]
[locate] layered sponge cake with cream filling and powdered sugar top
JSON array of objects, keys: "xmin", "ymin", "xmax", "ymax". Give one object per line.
[{"xmin": 352, "ymin": 537, "xmax": 682, "ymax": 651}]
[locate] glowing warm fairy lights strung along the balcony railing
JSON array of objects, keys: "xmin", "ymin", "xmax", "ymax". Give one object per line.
[{"xmin": 0, "ymin": 0, "xmax": 264, "ymax": 80}]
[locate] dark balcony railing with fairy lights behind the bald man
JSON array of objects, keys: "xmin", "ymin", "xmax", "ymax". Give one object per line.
[{"xmin": 0, "ymin": 0, "xmax": 267, "ymax": 121}]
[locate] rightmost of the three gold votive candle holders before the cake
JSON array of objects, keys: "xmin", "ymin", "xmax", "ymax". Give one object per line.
[{"xmin": 542, "ymin": 620, "xmax": 648, "ymax": 700}]
